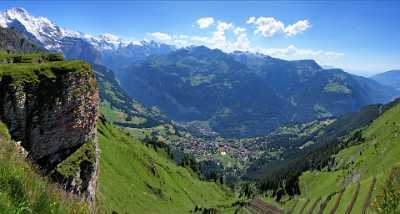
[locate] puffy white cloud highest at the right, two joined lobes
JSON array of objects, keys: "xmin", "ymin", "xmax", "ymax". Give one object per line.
[{"xmin": 246, "ymin": 16, "xmax": 311, "ymax": 37}]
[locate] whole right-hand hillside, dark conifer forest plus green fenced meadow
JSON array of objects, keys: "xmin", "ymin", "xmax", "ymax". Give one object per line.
[{"xmin": 247, "ymin": 101, "xmax": 400, "ymax": 213}]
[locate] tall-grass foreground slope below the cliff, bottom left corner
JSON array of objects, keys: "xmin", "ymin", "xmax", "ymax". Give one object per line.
[{"xmin": 0, "ymin": 122, "xmax": 89, "ymax": 214}]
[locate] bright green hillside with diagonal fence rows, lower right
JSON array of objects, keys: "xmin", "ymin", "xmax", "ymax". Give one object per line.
[{"xmin": 256, "ymin": 100, "xmax": 400, "ymax": 213}]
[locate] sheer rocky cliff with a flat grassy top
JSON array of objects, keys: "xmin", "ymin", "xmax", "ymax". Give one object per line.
[{"xmin": 0, "ymin": 55, "xmax": 99, "ymax": 198}]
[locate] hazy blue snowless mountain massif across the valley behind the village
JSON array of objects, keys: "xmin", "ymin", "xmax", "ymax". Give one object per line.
[{"xmin": 121, "ymin": 46, "xmax": 397, "ymax": 137}]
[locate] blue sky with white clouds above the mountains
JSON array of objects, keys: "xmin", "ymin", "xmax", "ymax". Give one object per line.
[{"xmin": 0, "ymin": 1, "xmax": 400, "ymax": 75}]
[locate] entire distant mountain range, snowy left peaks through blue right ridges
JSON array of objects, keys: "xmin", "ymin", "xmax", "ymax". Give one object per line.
[{"xmin": 0, "ymin": 8, "xmax": 399, "ymax": 137}]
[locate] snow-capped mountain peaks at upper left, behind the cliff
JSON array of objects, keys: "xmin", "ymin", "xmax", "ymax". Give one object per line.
[{"xmin": 0, "ymin": 8, "xmax": 176, "ymax": 69}]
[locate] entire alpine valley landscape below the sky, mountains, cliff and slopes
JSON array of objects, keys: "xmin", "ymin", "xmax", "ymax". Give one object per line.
[{"xmin": 0, "ymin": 8, "xmax": 400, "ymax": 214}]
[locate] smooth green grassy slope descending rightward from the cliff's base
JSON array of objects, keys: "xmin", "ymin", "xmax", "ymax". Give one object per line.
[{"xmin": 97, "ymin": 119, "xmax": 231, "ymax": 213}]
